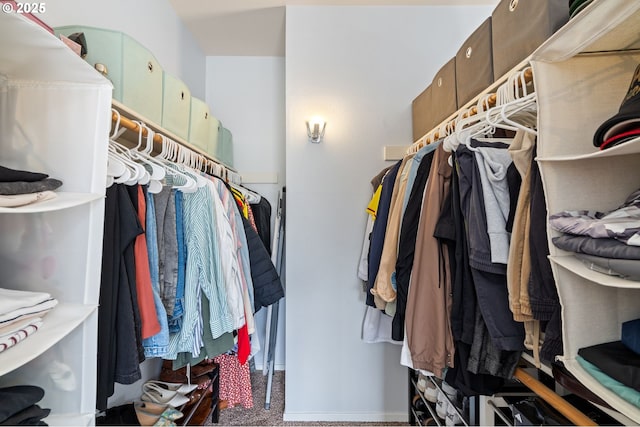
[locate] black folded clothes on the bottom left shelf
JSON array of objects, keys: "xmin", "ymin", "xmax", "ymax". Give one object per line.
[{"xmin": 0, "ymin": 385, "xmax": 51, "ymax": 426}]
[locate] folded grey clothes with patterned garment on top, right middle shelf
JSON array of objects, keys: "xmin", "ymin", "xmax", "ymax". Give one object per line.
[{"xmin": 549, "ymin": 190, "xmax": 640, "ymax": 280}]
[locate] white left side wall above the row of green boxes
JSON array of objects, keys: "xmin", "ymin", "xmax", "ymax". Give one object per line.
[{"xmin": 40, "ymin": 0, "xmax": 205, "ymax": 99}]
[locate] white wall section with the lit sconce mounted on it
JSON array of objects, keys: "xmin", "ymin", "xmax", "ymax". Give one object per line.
[{"xmin": 285, "ymin": 6, "xmax": 493, "ymax": 421}]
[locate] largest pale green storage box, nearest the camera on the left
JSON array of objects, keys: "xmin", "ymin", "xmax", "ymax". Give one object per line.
[{"xmin": 54, "ymin": 25, "xmax": 163, "ymax": 124}]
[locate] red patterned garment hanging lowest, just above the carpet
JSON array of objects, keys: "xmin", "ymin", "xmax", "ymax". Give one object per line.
[{"xmin": 213, "ymin": 354, "xmax": 253, "ymax": 409}]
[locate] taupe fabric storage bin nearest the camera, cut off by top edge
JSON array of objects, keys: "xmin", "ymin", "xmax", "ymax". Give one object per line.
[{"xmin": 491, "ymin": 0, "xmax": 569, "ymax": 80}]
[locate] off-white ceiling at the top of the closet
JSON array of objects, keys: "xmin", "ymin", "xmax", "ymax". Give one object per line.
[{"xmin": 169, "ymin": 0, "xmax": 498, "ymax": 56}]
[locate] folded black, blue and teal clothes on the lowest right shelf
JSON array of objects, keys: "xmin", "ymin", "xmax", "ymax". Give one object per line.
[{"xmin": 576, "ymin": 319, "xmax": 640, "ymax": 406}]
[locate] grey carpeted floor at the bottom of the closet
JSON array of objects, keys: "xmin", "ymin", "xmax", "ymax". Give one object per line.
[{"xmin": 211, "ymin": 371, "xmax": 408, "ymax": 426}]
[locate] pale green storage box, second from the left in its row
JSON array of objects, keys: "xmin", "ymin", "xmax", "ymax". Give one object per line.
[{"xmin": 161, "ymin": 72, "xmax": 191, "ymax": 141}]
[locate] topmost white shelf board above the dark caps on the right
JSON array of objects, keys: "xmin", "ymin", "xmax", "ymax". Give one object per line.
[{"xmin": 531, "ymin": 0, "xmax": 640, "ymax": 62}]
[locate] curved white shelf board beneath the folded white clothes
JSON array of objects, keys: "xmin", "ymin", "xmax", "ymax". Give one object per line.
[{"xmin": 0, "ymin": 303, "xmax": 98, "ymax": 376}]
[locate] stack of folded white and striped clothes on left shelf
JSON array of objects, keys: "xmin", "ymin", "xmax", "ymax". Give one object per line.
[{"xmin": 0, "ymin": 288, "xmax": 58, "ymax": 352}]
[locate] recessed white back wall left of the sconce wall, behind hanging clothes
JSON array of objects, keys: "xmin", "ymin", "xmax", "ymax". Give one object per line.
[{"xmin": 206, "ymin": 56, "xmax": 285, "ymax": 369}]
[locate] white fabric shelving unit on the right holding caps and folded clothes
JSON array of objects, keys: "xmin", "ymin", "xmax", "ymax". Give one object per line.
[{"xmin": 530, "ymin": 0, "xmax": 640, "ymax": 423}]
